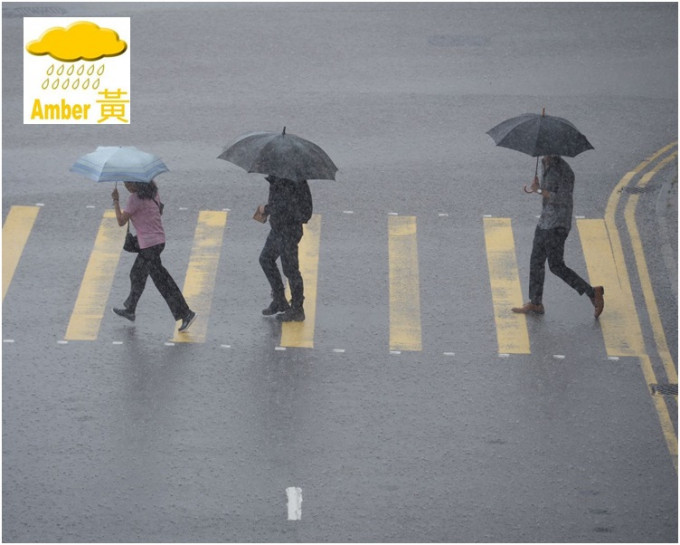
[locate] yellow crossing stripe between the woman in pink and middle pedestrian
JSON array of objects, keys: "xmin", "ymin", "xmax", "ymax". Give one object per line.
[{"xmin": 172, "ymin": 210, "xmax": 227, "ymax": 343}]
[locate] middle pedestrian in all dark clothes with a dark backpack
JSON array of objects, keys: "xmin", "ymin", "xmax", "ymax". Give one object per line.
[{"xmin": 258, "ymin": 176, "xmax": 312, "ymax": 322}]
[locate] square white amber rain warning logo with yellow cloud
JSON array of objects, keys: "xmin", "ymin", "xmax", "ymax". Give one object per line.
[{"xmin": 24, "ymin": 17, "xmax": 131, "ymax": 124}]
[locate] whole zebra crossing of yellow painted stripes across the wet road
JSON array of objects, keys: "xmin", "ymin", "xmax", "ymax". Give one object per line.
[{"xmin": 3, "ymin": 202, "xmax": 641, "ymax": 357}]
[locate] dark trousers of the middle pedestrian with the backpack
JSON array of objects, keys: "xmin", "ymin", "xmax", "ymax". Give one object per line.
[{"xmin": 260, "ymin": 224, "xmax": 304, "ymax": 307}]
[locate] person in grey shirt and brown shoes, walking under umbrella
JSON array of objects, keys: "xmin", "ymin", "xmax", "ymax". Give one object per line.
[{"xmin": 512, "ymin": 155, "xmax": 604, "ymax": 318}]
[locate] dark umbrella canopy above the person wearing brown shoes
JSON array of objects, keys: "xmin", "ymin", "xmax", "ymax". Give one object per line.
[{"xmin": 487, "ymin": 111, "xmax": 594, "ymax": 157}]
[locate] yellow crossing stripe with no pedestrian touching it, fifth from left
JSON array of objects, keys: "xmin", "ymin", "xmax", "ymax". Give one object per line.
[{"xmin": 388, "ymin": 216, "xmax": 423, "ymax": 351}]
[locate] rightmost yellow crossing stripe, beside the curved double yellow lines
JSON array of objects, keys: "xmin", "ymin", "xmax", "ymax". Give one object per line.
[{"xmin": 576, "ymin": 219, "xmax": 645, "ymax": 356}]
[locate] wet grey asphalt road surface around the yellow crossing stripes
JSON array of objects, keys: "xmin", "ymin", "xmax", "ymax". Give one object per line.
[{"xmin": 3, "ymin": 3, "xmax": 677, "ymax": 542}]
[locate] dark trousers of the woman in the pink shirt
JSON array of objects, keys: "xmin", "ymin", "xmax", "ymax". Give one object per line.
[{"xmin": 123, "ymin": 244, "xmax": 189, "ymax": 320}]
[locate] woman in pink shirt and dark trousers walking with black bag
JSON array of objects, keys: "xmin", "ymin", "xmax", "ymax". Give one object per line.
[{"xmin": 111, "ymin": 180, "xmax": 196, "ymax": 331}]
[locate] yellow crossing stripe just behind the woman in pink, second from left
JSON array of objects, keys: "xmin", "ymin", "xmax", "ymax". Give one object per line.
[{"xmin": 64, "ymin": 210, "xmax": 125, "ymax": 341}]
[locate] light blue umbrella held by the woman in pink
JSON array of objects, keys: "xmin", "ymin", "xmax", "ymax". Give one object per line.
[{"xmin": 70, "ymin": 146, "xmax": 169, "ymax": 182}]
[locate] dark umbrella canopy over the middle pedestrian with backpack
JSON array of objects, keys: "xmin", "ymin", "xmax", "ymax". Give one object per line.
[{"xmin": 218, "ymin": 127, "xmax": 338, "ymax": 181}]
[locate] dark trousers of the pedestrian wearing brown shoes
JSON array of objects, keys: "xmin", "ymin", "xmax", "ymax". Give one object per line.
[{"xmin": 529, "ymin": 223, "xmax": 594, "ymax": 305}]
